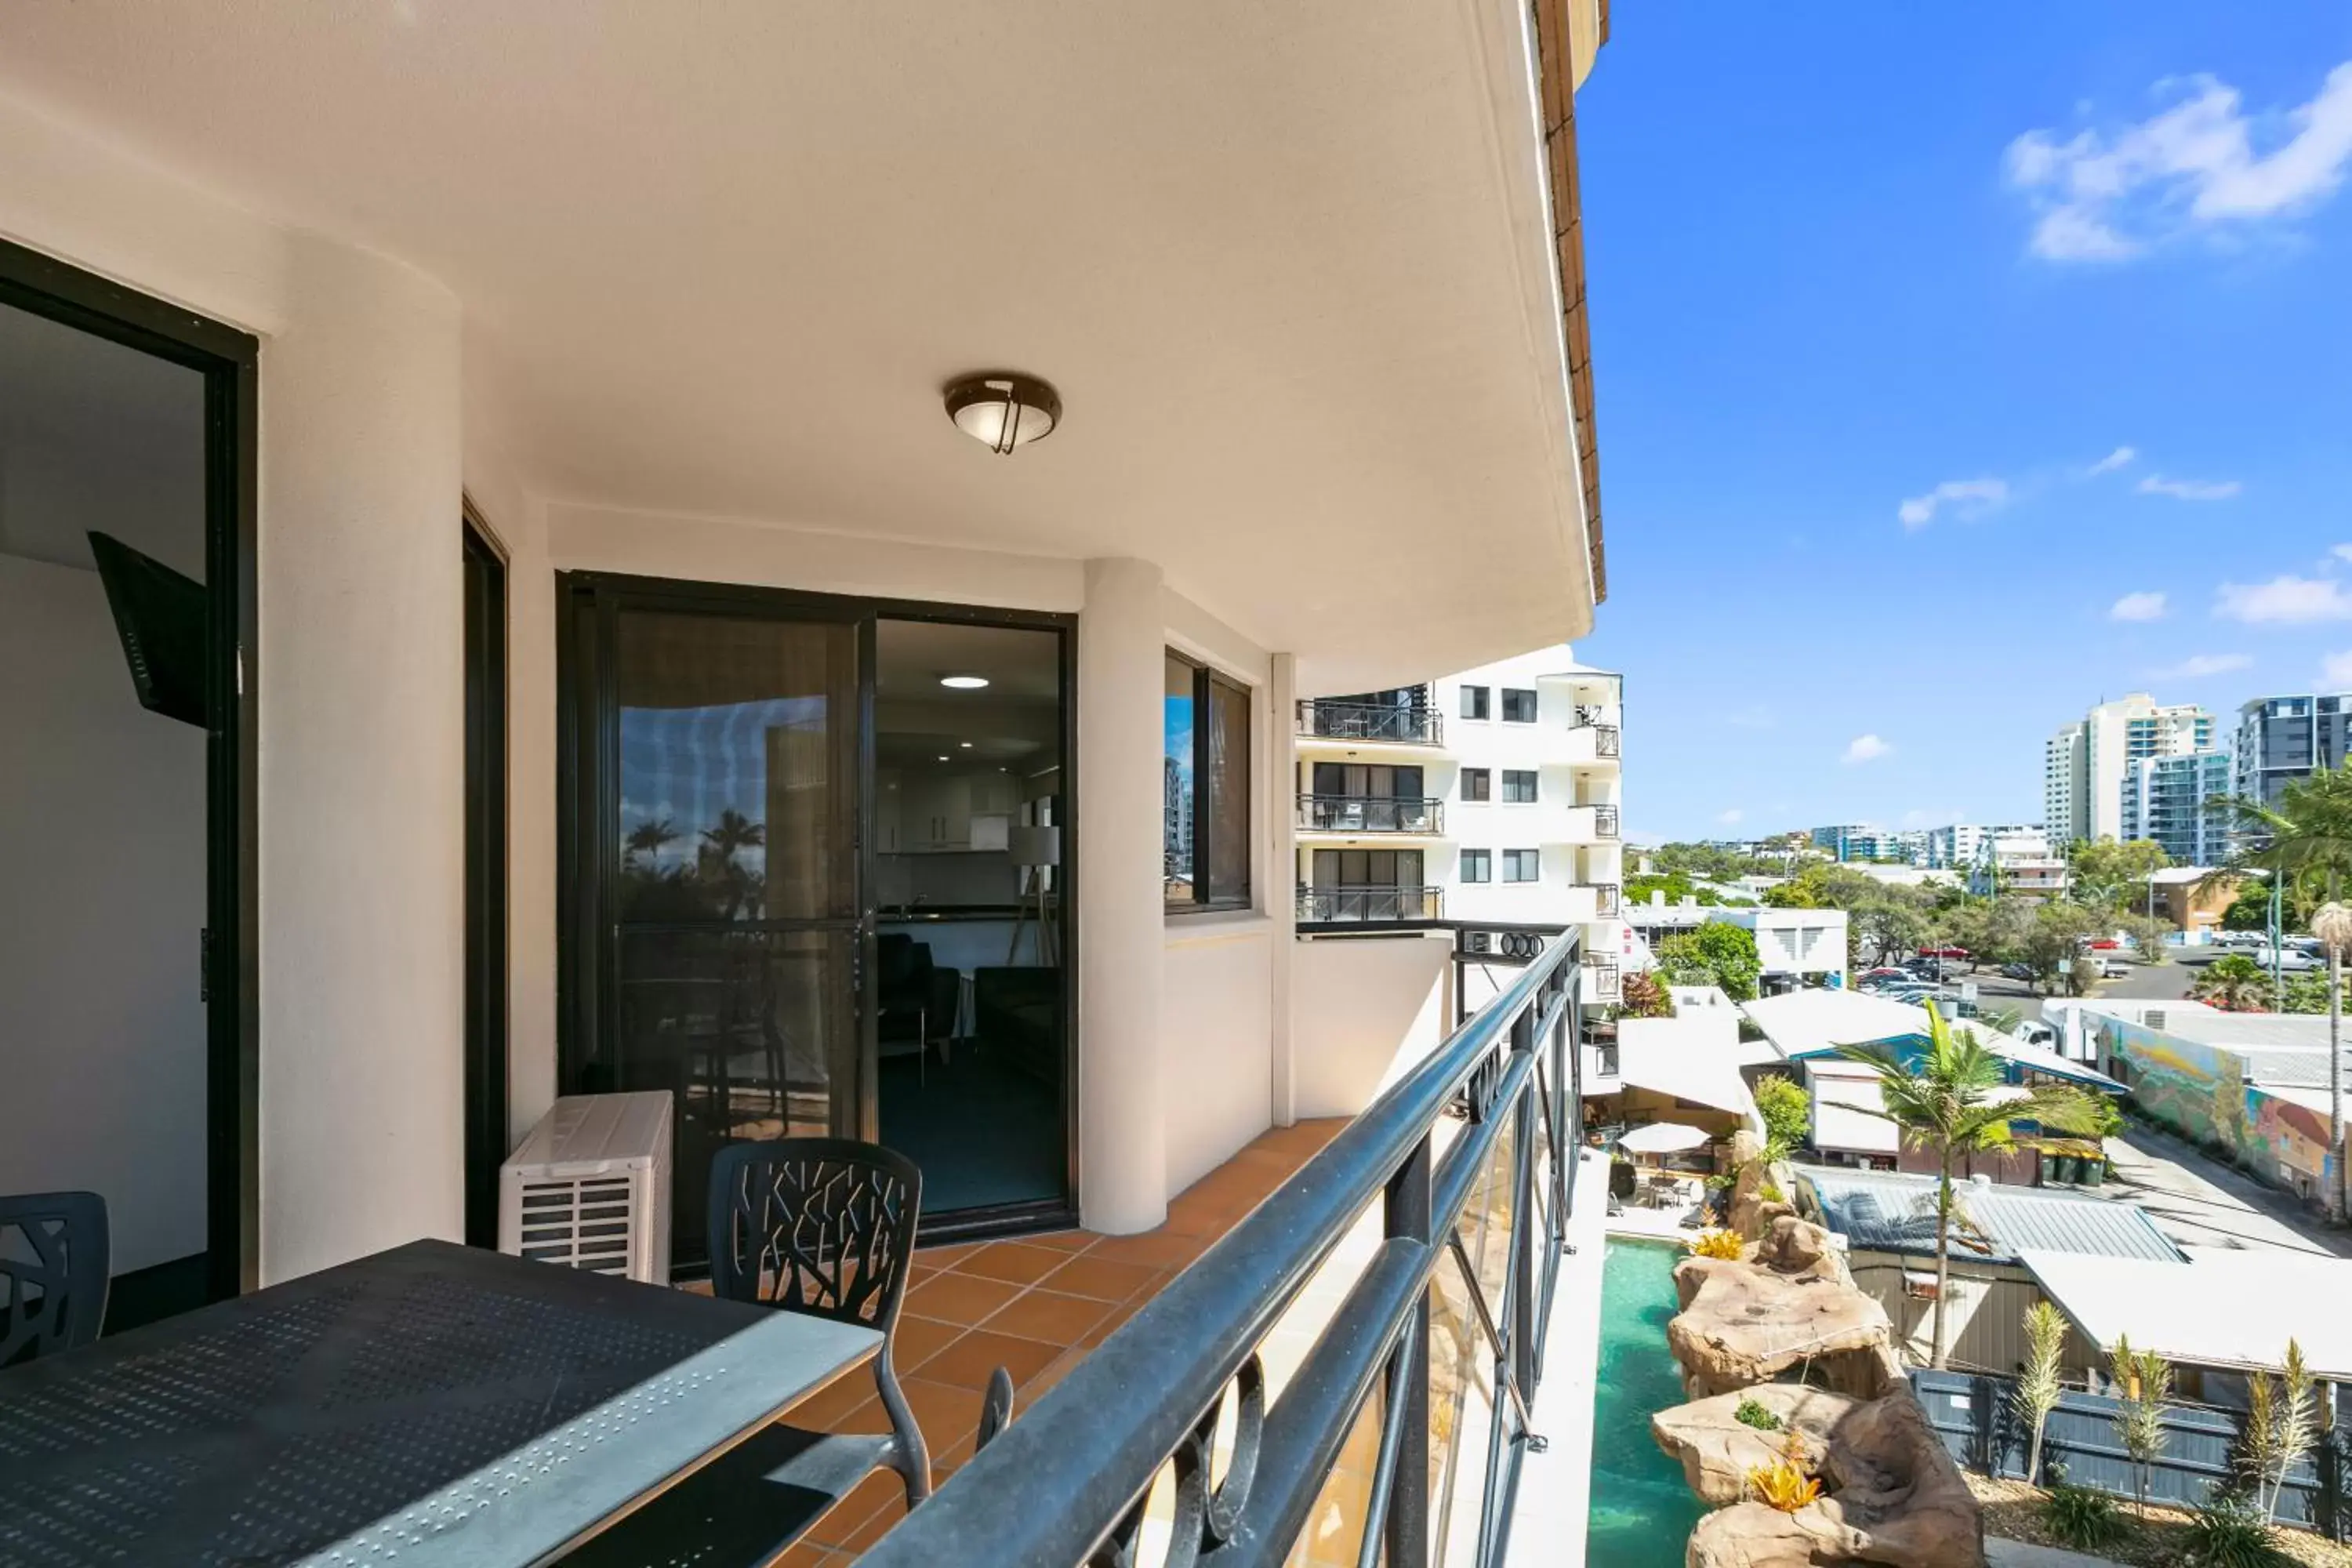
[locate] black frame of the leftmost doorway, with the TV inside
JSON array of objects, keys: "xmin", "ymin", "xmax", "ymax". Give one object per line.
[{"xmin": 0, "ymin": 240, "xmax": 261, "ymax": 1300}]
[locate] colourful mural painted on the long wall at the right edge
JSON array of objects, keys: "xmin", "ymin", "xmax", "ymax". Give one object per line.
[{"xmin": 2098, "ymin": 1018, "xmax": 2328, "ymax": 1192}]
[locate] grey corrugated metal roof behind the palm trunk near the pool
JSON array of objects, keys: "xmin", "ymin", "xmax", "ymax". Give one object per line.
[{"xmin": 1797, "ymin": 1166, "xmax": 2183, "ymax": 1262}]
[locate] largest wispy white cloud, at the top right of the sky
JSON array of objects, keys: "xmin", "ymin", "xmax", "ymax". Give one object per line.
[{"xmin": 2004, "ymin": 61, "xmax": 2352, "ymax": 261}]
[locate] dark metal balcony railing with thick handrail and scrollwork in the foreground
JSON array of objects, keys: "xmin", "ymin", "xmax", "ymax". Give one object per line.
[{"xmin": 861, "ymin": 935, "xmax": 1583, "ymax": 1568}]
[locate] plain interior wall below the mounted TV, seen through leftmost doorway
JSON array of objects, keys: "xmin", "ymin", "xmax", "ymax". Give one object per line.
[{"xmin": 0, "ymin": 555, "xmax": 205, "ymax": 1274}]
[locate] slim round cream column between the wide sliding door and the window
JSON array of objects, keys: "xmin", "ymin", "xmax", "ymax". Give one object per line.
[{"xmin": 1075, "ymin": 560, "xmax": 1167, "ymax": 1234}]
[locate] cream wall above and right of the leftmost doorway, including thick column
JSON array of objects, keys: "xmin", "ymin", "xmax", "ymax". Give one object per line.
[{"xmin": 0, "ymin": 89, "xmax": 463, "ymax": 1279}]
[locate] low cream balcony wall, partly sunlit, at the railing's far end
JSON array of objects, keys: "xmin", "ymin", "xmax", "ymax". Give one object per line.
[{"xmin": 1291, "ymin": 933, "xmax": 1449, "ymax": 1116}]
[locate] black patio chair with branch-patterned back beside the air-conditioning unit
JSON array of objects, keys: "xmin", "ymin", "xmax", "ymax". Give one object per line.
[{"xmin": 564, "ymin": 1138, "xmax": 931, "ymax": 1568}]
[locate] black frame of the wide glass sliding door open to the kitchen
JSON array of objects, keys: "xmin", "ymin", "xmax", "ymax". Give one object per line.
[{"xmin": 555, "ymin": 572, "xmax": 1082, "ymax": 1241}]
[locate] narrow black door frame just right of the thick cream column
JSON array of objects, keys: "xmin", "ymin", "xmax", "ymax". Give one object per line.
[{"xmin": 463, "ymin": 512, "xmax": 510, "ymax": 1248}]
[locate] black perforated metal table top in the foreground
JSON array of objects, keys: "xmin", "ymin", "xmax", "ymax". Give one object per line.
[{"xmin": 0, "ymin": 1241, "xmax": 882, "ymax": 1568}]
